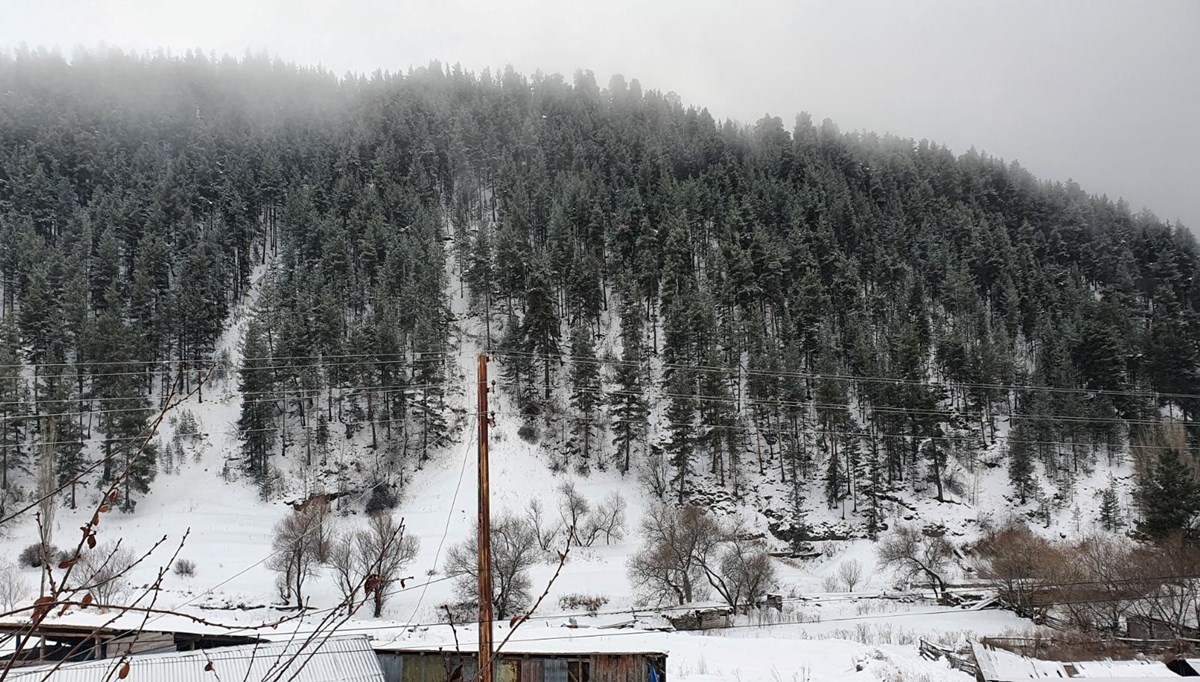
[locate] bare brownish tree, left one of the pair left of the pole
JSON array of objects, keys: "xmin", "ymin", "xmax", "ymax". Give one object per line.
[{"xmin": 266, "ymin": 505, "xmax": 332, "ymax": 609}]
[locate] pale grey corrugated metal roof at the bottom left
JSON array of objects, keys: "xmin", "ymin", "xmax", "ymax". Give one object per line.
[{"xmin": 8, "ymin": 636, "xmax": 384, "ymax": 682}]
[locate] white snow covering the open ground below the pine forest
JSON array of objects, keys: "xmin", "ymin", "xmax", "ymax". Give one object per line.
[{"xmin": 0, "ymin": 241, "xmax": 1108, "ymax": 682}]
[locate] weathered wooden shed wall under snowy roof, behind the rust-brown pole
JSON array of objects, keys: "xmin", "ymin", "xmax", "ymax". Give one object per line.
[{"xmin": 376, "ymin": 648, "xmax": 667, "ymax": 682}]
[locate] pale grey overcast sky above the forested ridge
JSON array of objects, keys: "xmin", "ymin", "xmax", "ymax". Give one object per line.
[{"xmin": 0, "ymin": 0, "xmax": 1200, "ymax": 229}]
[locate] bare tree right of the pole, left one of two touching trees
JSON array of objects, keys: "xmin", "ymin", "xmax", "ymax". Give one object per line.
[{"xmin": 628, "ymin": 504, "xmax": 721, "ymax": 604}]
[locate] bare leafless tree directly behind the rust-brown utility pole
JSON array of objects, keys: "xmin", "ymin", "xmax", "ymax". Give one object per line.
[{"xmin": 445, "ymin": 514, "xmax": 541, "ymax": 618}]
